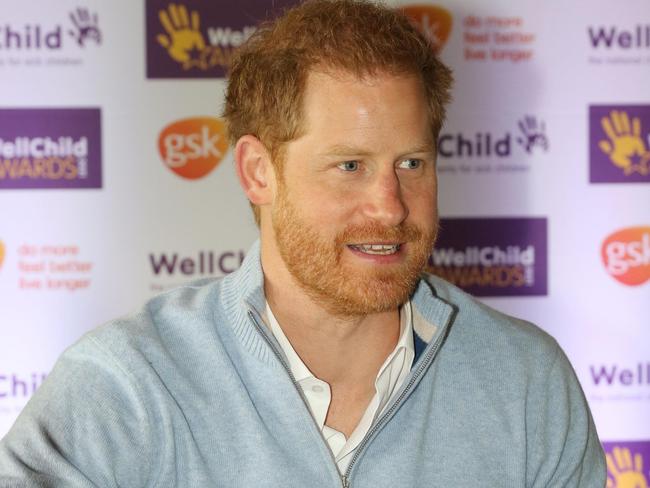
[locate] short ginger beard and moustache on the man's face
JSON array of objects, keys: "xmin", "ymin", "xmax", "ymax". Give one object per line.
[{"xmin": 272, "ymin": 179, "xmax": 436, "ymax": 317}]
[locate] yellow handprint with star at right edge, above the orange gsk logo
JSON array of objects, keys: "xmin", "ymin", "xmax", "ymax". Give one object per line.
[{"xmin": 598, "ymin": 110, "xmax": 650, "ymax": 175}]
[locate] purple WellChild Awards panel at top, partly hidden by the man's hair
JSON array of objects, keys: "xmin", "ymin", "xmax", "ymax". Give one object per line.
[{"xmin": 146, "ymin": 0, "xmax": 297, "ymax": 78}]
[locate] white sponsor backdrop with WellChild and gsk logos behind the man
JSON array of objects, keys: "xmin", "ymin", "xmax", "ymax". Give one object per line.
[{"xmin": 0, "ymin": 0, "xmax": 650, "ymax": 480}]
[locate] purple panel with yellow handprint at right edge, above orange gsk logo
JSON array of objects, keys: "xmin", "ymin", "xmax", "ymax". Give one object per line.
[{"xmin": 589, "ymin": 105, "xmax": 650, "ymax": 183}]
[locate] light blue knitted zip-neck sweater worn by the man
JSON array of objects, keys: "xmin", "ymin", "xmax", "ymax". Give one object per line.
[{"xmin": 0, "ymin": 244, "xmax": 606, "ymax": 488}]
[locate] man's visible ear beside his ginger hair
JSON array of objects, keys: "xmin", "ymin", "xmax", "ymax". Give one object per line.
[{"xmin": 235, "ymin": 134, "xmax": 275, "ymax": 205}]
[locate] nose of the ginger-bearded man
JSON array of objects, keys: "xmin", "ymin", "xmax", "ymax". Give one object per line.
[{"xmin": 364, "ymin": 168, "xmax": 409, "ymax": 226}]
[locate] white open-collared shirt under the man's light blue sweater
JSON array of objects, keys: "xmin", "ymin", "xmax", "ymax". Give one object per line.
[{"xmin": 266, "ymin": 301, "xmax": 415, "ymax": 473}]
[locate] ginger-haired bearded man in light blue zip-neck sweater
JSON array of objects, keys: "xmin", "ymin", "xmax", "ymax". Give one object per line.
[{"xmin": 0, "ymin": 0, "xmax": 605, "ymax": 488}]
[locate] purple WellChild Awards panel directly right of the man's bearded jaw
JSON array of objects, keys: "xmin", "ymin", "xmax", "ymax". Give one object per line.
[{"xmin": 428, "ymin": 218, "xmax": 547, "ymax": 296}]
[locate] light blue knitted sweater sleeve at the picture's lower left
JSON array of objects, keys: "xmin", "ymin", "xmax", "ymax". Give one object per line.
[{"xmin": 0, "ymin": 337, "xmax": 152, "ymax": 488}]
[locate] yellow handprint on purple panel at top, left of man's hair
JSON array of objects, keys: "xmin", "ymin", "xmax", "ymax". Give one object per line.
[{"xmin": 156, "ymin": 3, "xmax": 207, "ymax": 69}]
